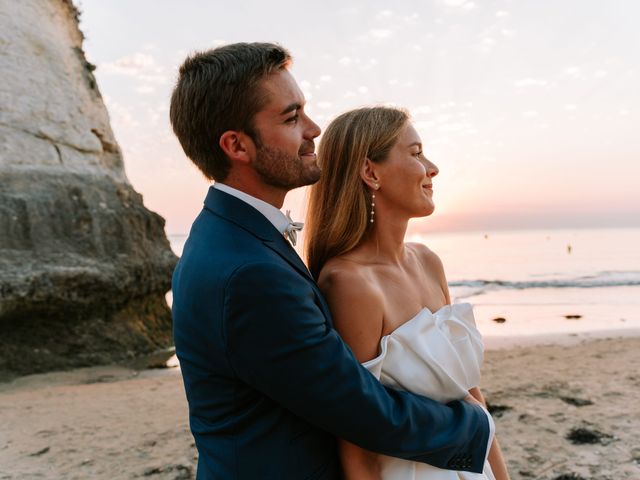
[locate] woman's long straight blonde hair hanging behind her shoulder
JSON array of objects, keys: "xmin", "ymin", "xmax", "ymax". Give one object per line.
[{"xmin": 305, "ymin": 107, "xmax": 409, "ymax": 279}]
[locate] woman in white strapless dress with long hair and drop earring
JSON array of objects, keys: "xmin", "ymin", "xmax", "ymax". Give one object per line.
[{"xmin": 306, "ymin": 107, "xmax": 508, "ymax": 480}]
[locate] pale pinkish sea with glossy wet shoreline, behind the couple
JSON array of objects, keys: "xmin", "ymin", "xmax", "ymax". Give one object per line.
[{"xmin": 169, "ymin": 228, "xmax": 640, "ymax": 348}]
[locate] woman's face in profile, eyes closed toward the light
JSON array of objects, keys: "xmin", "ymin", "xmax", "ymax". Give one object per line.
[{"xmin": 375, "ymin": 122, "xmax": 438, "ymax": 218}]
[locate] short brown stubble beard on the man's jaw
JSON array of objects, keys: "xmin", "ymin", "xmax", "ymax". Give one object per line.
[{"xmin": 253, "ymin": 145, "xmax": 320, "ymax": 191}]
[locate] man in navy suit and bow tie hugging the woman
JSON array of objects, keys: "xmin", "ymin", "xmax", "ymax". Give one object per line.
[{"xmin": 171, "ymin": 43, "xmax": 493, "ymax": 480}]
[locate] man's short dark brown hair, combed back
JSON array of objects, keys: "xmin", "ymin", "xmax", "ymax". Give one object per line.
[{"xmin": 169, "ymin": 43, "xmax": 291, "ymax": 181}]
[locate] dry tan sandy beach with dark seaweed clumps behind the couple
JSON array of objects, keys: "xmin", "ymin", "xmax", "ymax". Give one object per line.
[{"xmin": 0, "ymin": 337, "xmax": 640, "ymax": 480}]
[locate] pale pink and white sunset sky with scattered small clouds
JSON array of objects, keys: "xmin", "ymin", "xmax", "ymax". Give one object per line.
[{"xmin": 75, "ymin": 0, "xmax": 640, "ymax": 234}]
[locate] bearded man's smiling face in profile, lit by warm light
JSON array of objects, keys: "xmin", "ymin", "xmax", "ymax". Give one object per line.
[{"xmin": 253, "ymin": 69, "xmax": 320, "ymax": 191}]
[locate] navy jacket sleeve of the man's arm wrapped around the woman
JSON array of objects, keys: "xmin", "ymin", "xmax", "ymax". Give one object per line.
[{"xmin": 223, "ymin": 262, "xmax": 489, "ymax": 472}]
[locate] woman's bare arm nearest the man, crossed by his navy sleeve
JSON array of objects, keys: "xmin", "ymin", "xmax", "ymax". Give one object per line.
[{"xmin": 318, "ymin": 264, "xmax": 383, "ymax": 480}]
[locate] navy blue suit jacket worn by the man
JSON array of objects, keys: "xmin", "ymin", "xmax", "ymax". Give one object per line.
[{"xmin": 173, "ymin": 188, "xmax": 489, "ymax": 480}]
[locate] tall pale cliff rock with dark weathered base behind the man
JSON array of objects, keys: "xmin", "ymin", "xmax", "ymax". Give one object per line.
[{"xmin": 0, "ymin": 0, "xmax": 176, "ymax": 376}]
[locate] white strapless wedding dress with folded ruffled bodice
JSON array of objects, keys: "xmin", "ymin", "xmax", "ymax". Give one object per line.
[{"xmin": 363, "ymin": 303, "xmax": 495, "ymax": 480}]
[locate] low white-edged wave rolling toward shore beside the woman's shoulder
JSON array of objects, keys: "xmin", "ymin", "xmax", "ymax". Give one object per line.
[{"xmin": 449, "ymin": 271, "xmax": 640, "ymax": 291}]
